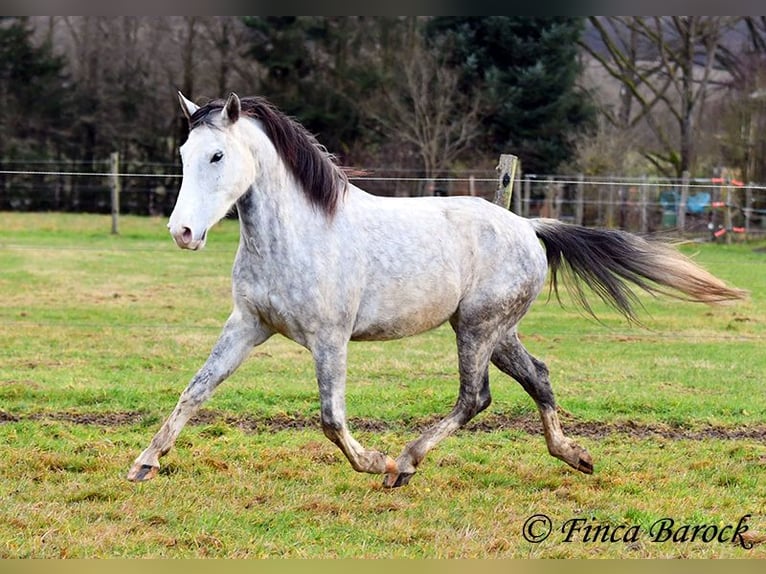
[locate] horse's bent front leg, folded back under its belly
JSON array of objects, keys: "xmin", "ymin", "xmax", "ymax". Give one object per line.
[{"xmin": 312, "ymin": 342, "xmax": 396, "ymax": 480}]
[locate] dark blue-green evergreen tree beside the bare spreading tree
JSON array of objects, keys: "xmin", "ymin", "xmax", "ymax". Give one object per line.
[{"xmin": 428, "ymin": 16, "xmax": 595, "ymax": 173}]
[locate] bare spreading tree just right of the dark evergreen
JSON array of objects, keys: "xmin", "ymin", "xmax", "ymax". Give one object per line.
[{"xmin": 581, "ymin": 16, "xmax": 735, "ymax": 177}]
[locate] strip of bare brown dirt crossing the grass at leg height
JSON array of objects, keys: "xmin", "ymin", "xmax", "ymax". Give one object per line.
[{"xmin": 6, "ymin": 409, "xmax": 766, "ymax": 441}]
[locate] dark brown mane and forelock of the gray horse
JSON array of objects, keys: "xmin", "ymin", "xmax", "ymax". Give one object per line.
[{"xmin": 189, "ymin": 96, "xmax": 347, "ymax": 215}]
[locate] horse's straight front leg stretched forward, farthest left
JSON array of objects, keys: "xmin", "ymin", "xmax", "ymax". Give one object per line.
[{"xmin": 127, "ymin": 308, "xmax": 271, "ymax": 482}]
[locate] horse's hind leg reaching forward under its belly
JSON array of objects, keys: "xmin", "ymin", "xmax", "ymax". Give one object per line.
[{"xmin": 383, "ymin": 327, "xmax": 494, "ymax": 488}]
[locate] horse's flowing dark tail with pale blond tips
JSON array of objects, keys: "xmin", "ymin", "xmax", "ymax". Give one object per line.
[{"xmin": 530, "ymin": 219, "xmax": 747, "ymax": 322}]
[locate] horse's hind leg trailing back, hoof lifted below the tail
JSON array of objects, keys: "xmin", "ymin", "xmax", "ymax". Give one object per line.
[{"xmin": 492, "ymin": 329, "xmax": 593, "ymax": 474}]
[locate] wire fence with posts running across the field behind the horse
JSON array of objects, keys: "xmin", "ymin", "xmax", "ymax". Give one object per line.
[{"xmin": 0, "ymin": 160, "xmax": 766, "ymax": 239}]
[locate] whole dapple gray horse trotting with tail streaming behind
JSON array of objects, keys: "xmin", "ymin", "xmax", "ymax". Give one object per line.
[{"xmin": 128, "ymin": 94, "xmax": 745, "ymax": 487}]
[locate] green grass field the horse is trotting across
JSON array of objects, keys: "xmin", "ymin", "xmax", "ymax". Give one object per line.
[{"xmin": 0, "ymin": 213, "xmax": 766, "ymax": 558}]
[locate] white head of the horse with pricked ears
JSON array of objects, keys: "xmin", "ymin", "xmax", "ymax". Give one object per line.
[{"xmin": 168, "ymin": 92, "xmax": 255, "ymax": 250}]
